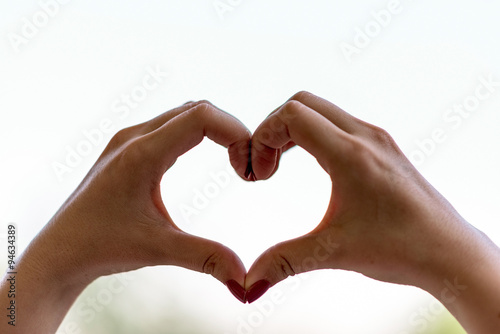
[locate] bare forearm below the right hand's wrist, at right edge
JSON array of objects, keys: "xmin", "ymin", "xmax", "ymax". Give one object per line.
[{"xmin": 427, "ymin": 226, "xmax": 500, "ymax": 334}]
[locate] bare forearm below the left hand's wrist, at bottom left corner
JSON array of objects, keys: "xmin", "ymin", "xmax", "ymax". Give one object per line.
[{"xmin": 0, "ymin": 223, "xmax": 91, "ymax": 334}]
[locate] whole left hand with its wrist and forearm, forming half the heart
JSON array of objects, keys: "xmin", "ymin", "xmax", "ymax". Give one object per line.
[{"xmin": 0, "ymin": 101, "xmax": 250, "ymax": 333}]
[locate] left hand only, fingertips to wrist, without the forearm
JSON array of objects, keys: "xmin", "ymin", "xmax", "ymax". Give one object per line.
[{"xmin": 49, "ymin": 101, "xmax": 250, "ymax": 285}]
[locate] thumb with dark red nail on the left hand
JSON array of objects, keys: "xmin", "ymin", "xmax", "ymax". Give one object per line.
[{"xmin": 166, "ymin": 230, "xmax": 246, "ymax": 303}]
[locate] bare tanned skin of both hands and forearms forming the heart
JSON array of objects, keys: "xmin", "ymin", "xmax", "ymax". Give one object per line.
[{"xmin": 0, "ymin": 92, "xmax": 500, "ymax": 333}]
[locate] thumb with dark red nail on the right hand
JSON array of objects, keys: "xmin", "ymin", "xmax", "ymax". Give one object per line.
[{"xmin": 245, "ymin": 233, "xmax": 339, "ymax": 303}]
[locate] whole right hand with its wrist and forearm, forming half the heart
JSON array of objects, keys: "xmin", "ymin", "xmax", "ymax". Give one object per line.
[{"xmin": 245, "ymin": 92, "xmax": 500, "ymax": 332}]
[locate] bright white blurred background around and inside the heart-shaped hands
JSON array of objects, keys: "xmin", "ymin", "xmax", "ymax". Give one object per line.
[{"xmin": 0, "ymin": 0, "xmax": 500, "ymax": 333}]
